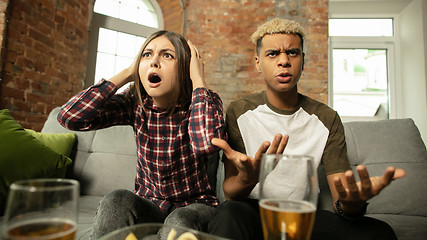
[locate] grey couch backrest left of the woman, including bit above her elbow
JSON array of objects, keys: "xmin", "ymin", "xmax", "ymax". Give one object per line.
[{"xmin": 42, "ymin": 108, "xmax": 137, "ymax": 196}]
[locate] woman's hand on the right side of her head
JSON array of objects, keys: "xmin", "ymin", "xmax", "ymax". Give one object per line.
[{"xmin": 187, "ymin": 40, "xmax": 206, "ymax": 90}]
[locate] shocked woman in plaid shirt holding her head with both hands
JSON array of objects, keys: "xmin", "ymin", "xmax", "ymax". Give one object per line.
[{"xmin": 58, "ymin": 31, "xmax": 225, "ymax": 239}]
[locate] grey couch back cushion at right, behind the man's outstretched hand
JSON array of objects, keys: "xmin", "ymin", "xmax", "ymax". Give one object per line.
[{"xmin": 344, "ymin": 119, "xmax": 427, "ymax": 216}]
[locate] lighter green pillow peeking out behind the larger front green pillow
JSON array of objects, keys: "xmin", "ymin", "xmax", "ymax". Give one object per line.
[{"xmin": 25, "ymin": 129, "xmax": 76, "ymax": 157}]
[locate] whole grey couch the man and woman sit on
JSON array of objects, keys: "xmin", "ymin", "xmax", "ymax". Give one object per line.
[{"xmin": 10, "ymin": 108, "xmax": 427, "ymax": 240}]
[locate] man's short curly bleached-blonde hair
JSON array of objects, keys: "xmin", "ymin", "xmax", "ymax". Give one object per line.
[{"xmin": 251, "ymin": 18, "xmax": 305, "ymax": 53}]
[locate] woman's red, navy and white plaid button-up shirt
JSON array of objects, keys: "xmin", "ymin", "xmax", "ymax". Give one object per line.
[{"xmin": 58, "ymin": 80, "xmax": 225, "ymax": 212}]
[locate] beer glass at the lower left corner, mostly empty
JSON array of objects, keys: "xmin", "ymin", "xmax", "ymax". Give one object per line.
[{"xmin": 2, "ymin": 179, "xmax": 80, "ymax": 240}]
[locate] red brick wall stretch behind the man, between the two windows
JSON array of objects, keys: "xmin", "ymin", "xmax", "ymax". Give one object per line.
[{"xmin": 184, "ymin": 0, "xmax": 328, "ymax": 106}]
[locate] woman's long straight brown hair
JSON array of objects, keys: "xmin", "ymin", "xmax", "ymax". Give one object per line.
[{"xmin": 125, "ymin": 30, "xmax": 193, "ymax": 115}]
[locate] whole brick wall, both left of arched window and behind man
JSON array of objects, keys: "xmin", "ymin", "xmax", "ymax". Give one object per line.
[{"xmin": 0, "ymin": 0, "xmax": 328, "ymax": 130}]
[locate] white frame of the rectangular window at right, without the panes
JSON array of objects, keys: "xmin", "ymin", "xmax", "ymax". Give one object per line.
[{"xmin": 328, "ymin": 14, "xmax": 401, "ymax": 122}]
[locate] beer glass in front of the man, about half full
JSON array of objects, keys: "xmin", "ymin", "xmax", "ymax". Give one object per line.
[{"xmin": 259, "ymin": 154, "xmax": 319, "ymax": 240}]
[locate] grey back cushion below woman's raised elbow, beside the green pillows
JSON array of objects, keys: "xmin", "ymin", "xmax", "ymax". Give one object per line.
[{"xmin": 76, "ymin": 126, "xmax": 137, "ymax": 196}]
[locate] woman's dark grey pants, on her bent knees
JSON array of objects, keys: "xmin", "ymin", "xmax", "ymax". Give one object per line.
[{"xmin": 90, "ymin": 190, "xmax": 215, "ymax": 239}]
